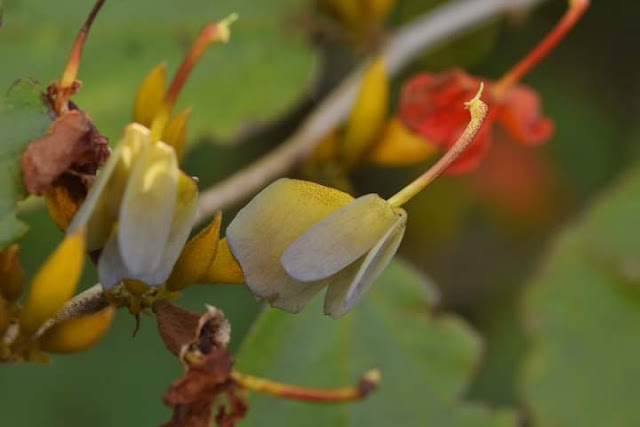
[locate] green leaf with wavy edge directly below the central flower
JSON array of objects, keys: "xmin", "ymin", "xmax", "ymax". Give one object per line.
[{"xmin": 237, "ymin": 262, "xmax": 515, "ymax": 426}]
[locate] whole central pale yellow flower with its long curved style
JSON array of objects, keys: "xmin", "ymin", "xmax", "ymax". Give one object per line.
[{"xmin": 227, "ymin": 86, "xmax": 487, "ymax": 318}]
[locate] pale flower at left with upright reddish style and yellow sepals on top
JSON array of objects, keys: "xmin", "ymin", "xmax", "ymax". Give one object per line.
[{"xmin": 68, "ymin": 15, "xmax": 236, "ymax": 290}]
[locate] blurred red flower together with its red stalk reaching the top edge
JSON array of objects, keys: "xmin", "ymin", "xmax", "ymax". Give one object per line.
[{"xmin": 398, "ymin": 0, "xmax": 589, "ymax": 174}]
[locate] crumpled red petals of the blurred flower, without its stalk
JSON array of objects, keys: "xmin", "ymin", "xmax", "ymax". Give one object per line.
[{"xmin": 398, "ymin": 69, "xmax": 553, "ymax": 174}]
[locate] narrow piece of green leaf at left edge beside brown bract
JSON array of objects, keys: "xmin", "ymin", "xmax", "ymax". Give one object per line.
[{"xmin": 0, "ymin": 80, "xmax": 52, "ymax": 250}]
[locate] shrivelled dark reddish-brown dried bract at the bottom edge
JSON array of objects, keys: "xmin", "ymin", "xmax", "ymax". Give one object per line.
[{"xmin": 153, "ymin": 300, "xmax": 247, "ymax": 427}]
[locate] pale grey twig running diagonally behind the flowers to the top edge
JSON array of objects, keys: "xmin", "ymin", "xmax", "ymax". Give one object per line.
[{"xmin": 196, "ymin": 0, "xmax": 544, "ymax": 224}]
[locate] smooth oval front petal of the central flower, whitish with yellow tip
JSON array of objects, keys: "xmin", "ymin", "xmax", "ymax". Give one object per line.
[{"xmin": 280, "ymin": 194, "xmax": 398, "ymax": 282}]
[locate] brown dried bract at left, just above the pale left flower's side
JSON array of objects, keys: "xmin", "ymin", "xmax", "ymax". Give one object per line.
[{"xmin": 22, "ymin": 105, "xmax": 109, "ymax": 195}]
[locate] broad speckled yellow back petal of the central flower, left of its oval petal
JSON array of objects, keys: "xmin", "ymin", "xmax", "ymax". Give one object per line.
[{"xmin": 227, "ymin": 178, "xmax": 353, "ymax": 313}]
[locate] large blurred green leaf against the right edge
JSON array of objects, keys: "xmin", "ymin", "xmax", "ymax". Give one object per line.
[{"xmin": 523, "ymin": 169, "xmax": 640, "ymax": 426}]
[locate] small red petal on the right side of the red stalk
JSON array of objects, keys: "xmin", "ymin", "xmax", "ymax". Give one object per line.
[{"xmin": 497, "ymin": 85, "xmax": 553, "ymax": 145}]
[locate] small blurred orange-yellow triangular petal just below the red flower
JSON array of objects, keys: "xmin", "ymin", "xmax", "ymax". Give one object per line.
[{"xmin": 367, "ymin": 117, "xmax": 438, "ymax": 166}]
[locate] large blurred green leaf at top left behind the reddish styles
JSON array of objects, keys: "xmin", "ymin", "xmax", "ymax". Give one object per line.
[{"xmin": 0, "ymin": 0, "xmax": 314, "ymax": 141}]
